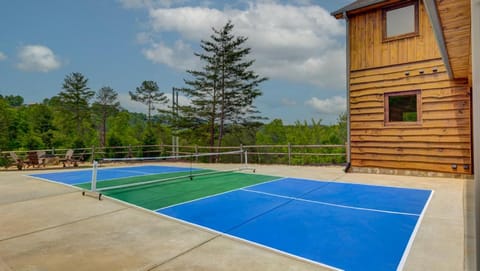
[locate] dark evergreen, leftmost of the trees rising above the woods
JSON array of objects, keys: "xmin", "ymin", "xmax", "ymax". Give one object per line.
[{"xmin": 58, "ymin": 72, "xmax": 95, "ymax": 140}]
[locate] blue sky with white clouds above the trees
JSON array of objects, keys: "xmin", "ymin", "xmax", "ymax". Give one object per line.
[{"xmin": 0, "ymin": 0, "xmax": 352, "ymax": 124}]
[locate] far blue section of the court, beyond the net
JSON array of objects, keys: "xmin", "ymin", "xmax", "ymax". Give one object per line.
[{"xmin": 30, "ymin": 166, "xmax": 198, "ymax": 185}]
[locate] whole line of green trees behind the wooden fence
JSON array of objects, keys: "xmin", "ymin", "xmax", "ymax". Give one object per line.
[{"xmin": 0, "ymin": 22, "xmax": 346, "ymax": 162}]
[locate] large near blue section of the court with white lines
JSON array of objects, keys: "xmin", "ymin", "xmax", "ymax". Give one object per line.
[{"xmin": 157, "ymin": 178, "xmax": 432, "ymax": 270}]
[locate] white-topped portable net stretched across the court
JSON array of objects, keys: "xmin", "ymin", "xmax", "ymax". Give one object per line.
[{"xmin": 84, "ymin": 150, "xmax": 251, "ymax": 196}]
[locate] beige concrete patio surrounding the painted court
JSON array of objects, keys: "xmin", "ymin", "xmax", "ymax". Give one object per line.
[{"xmin": 0, "ymin": 163, "xmax": 475, "ymax": 271}]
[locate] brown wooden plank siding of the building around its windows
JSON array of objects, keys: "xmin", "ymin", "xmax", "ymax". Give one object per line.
[{"xmin": 349, "ymin": 1, "xmax": 472, "ymax": 174}]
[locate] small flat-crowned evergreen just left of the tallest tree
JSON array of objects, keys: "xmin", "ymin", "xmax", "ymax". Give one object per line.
[{"xmin": 128, "ymin": 81, "xmax": 168, "ymax": 124}]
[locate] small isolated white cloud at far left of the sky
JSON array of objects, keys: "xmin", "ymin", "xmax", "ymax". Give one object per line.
[{"xmin": 17, "ymin": 45, "xmax": 61, "ymax": 72}]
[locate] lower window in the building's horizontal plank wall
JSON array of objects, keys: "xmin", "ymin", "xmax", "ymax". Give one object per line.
[{"xmin": 385, "ymin": 90, "xmax": 421, "ymax": 124}]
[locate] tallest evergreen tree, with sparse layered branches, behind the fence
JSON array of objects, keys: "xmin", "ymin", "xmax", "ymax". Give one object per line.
[{"xmin": 180, "ymin": 21, "xmax": 267, "ymax": 147}]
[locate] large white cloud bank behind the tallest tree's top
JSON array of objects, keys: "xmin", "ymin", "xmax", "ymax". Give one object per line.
[{"xmin": 142, "ymin": 1, "xmax": 345, "ymax": 89}]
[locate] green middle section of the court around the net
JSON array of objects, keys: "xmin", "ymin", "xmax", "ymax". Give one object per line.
[{"xmin": 76, "ymin": 170, "xmax": 279, "ymax": 210}]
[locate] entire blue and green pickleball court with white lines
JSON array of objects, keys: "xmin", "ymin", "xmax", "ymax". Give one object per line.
[{"xmin": 31, "ymin": 166, "xmax": 432, "ymax": 270}]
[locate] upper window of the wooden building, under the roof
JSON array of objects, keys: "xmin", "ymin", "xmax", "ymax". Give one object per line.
[{"xmin": 383, "ymin": 1, "xmax": 418, "ymax": 41}]
